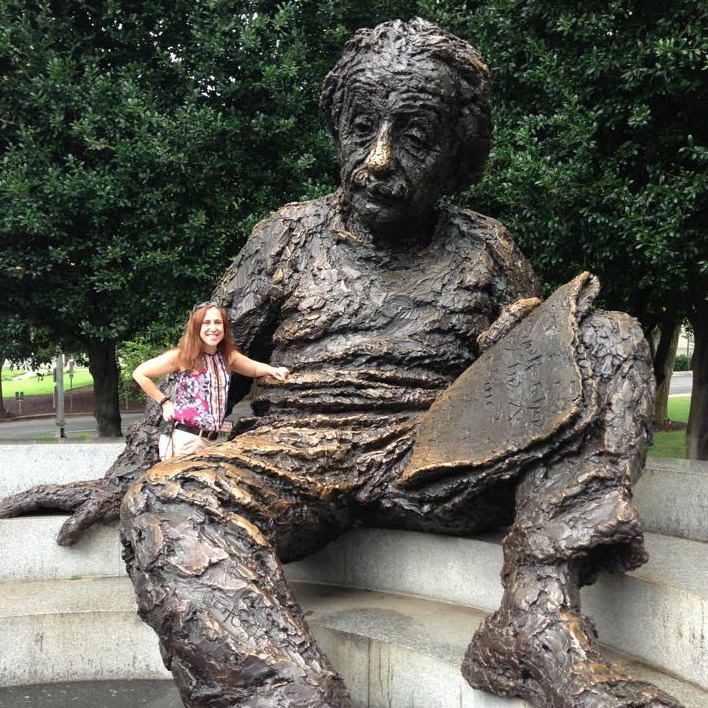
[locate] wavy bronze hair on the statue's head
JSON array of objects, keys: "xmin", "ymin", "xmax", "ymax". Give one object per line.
[{"xmin": 320, "ymin": 18, "xmax": 492, "ymax": 193}]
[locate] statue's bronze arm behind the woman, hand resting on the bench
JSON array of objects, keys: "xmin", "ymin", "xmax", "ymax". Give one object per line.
[{"xmin": 0, "ymin": 210, "xmax": 296, "ymax": 546}]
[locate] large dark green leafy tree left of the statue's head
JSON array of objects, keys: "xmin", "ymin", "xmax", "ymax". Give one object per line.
[{"xmin": 0, "ymin": 0, "xmax": 478, "ymax": 435}]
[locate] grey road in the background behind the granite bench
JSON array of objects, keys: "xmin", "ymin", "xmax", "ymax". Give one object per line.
[{"xmin": 0, "ymin": 371, "xmax": 693, "ymax": 442}]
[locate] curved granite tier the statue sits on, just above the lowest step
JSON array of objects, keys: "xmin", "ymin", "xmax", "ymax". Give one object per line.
[{"xmin": 0, "ymin": 516, "xmax": 708, "ymax": 687}]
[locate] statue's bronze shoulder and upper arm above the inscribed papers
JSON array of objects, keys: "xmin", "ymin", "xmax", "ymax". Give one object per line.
[{"xmin": 445, "ymin": 206, "xmax": 540, "ymax": 298}]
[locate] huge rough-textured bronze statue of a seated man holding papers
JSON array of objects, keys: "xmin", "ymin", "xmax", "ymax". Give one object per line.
[{"xmin": 2, "ymin": 20, "xmax": 677, "ymax": 708}]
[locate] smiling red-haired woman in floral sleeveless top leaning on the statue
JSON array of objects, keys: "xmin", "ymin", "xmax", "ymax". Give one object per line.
[{"xmin": 133, "ymin": 302, "xmax": 290, "ymax": 457}]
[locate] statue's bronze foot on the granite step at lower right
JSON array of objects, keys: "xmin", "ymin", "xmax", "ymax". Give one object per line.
[{"xmin": 462, "ymin": 611, "xmax": 681, "ymax": 708}]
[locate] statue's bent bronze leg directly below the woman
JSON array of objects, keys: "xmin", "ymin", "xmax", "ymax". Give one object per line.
[{"xmin": 121, "ymin": 441, "xmax": 356, "ymax": 708}]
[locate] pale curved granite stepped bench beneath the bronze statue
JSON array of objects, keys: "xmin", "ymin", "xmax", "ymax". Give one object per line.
[{"xmin": 0, "ymin": 443, "xmax": 708, "ymax": 708}]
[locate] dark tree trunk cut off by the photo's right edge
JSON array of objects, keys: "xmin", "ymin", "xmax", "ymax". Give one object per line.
[{"xmin": 686, "ymin": 275, "xmax": 708, "ymax": 460}]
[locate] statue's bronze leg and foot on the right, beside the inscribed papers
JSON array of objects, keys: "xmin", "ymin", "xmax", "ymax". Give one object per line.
[{"xmin": 462, "ymin": 313, "xmax": 677, "ymax": 708}]
